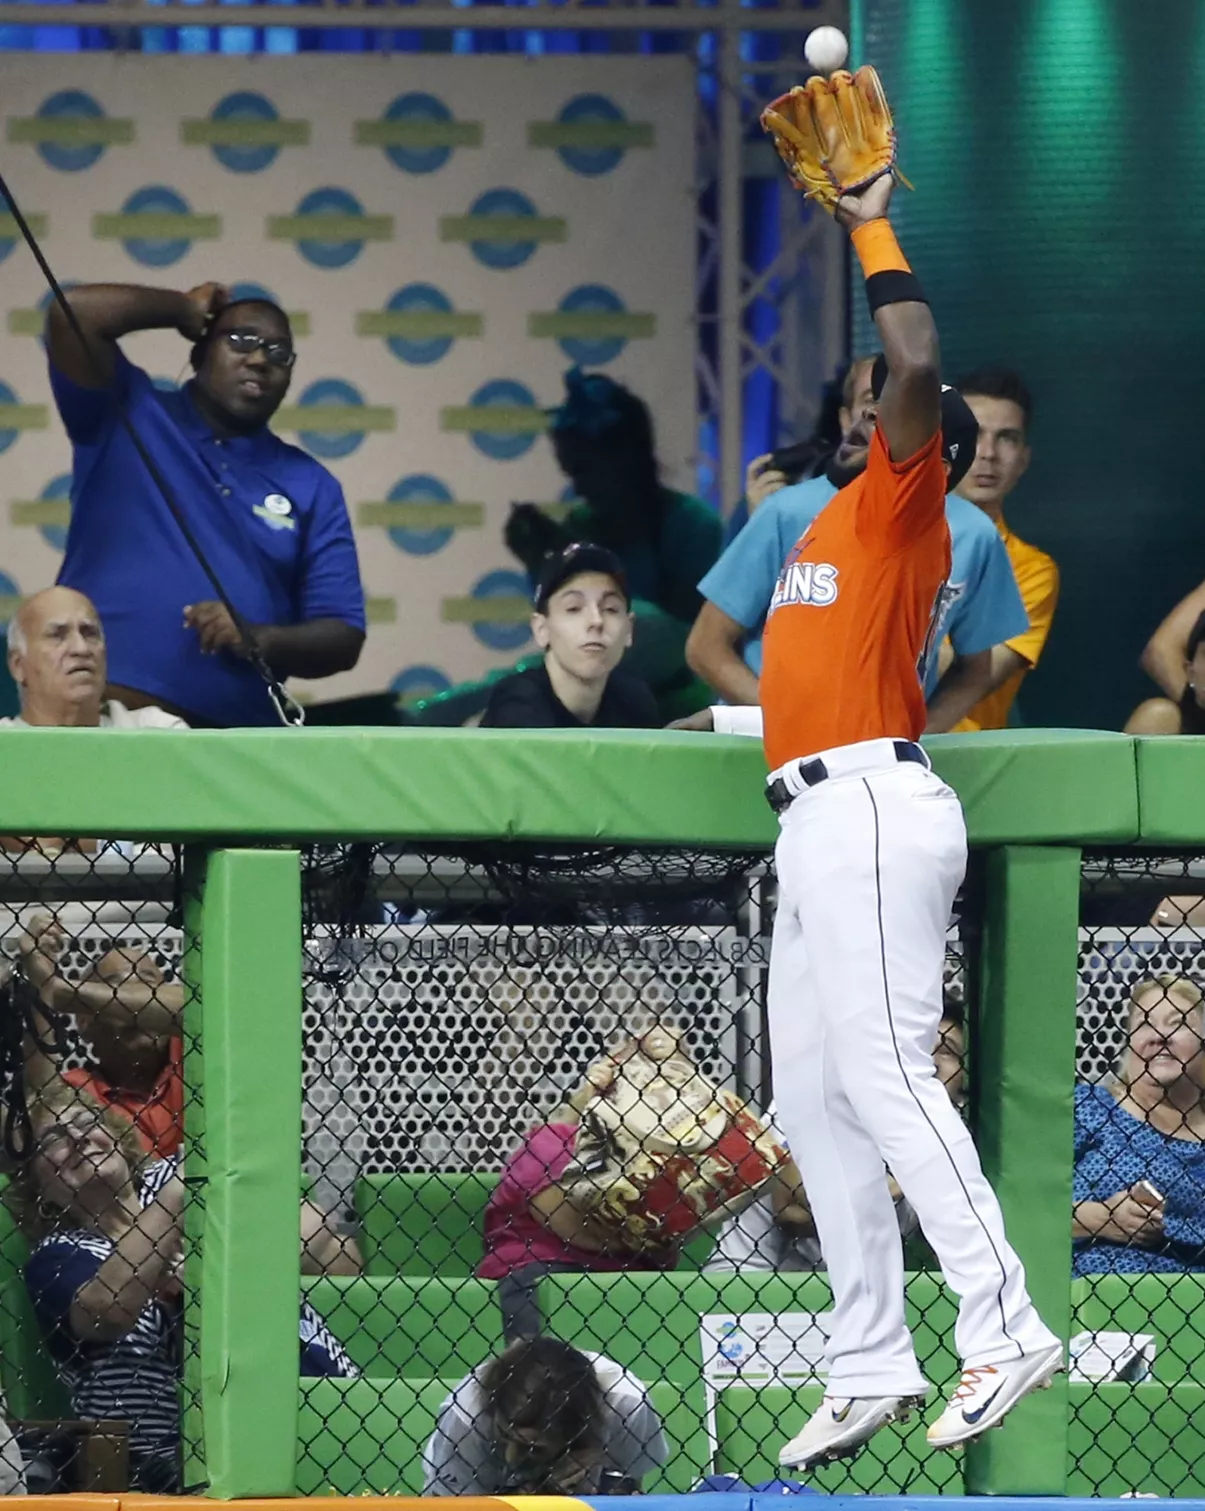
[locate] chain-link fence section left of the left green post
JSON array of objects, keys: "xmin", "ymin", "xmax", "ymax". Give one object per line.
[{"xmin": 0, "ymin": 840, "xmax": 193, "ymax": 1491}]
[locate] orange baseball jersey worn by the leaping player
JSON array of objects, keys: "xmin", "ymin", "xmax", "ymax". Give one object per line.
[{"xmin": 760, "ymin": 431, "xmax": 949, "ymax": 771}]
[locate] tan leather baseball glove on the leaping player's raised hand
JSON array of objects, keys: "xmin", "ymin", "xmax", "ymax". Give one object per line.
[{"xmin": 762, "ymin": 66, "xmax": 897, "ymax": 214}]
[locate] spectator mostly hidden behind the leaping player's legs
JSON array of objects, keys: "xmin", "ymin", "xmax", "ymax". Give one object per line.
[{"xmin": 703, "ymin": 993, "xmax": 966, "ymax": 1272}]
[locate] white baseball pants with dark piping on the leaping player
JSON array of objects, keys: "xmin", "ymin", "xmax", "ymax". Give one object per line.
[{"xmin": 770, "ymin": 740, "xmax": 1055, "ymax": 1396}]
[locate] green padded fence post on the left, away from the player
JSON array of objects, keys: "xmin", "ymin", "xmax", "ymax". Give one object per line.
[{"xmin": 192, "ymin": 849, "xmax": 302, "ymax": 1499}]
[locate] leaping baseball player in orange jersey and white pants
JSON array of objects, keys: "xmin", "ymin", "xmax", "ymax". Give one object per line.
[{"xmin": 680, "ymin": 68, "xmax": 1063, "ymax": 1467}]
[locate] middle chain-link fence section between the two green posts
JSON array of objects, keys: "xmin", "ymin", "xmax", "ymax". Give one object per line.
[{"xmin": 298, "ymin": 842, "xmax": 978, "ymax": 1494}]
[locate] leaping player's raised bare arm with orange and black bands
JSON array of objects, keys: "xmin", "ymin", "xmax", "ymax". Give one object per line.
[{"xmin": 836, "ymin": 174, "xmax": 942, "ymax": 462}]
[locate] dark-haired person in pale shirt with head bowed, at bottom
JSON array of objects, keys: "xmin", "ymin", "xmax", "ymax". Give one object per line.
[{"xmin": 423, "ymin": 1337, "xmax": 670, "ymax": 1496}]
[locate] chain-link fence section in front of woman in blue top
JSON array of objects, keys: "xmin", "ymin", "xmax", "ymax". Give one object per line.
[{"xmin": 1069, "ymin": 854, "xmax": 1205, "ymax": 1496}]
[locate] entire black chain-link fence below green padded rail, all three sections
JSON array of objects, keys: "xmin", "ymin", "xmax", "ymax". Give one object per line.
[{"xmin": 0, "ymin": 842, "xmax": 1205, "ymax": 1494}]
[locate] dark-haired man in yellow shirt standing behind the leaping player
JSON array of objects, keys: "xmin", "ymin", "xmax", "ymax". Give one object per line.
[{"xmin": 954, "ymin": 367, "xmax": 1058, "ymax": 733}]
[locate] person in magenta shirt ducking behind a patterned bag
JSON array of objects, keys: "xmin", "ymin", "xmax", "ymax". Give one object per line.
[{"xmin": 478, "ymin": 1052, "xmax": 679, "ymax": 1342}]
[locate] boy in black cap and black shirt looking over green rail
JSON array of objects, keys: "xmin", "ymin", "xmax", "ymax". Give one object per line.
[{"xmin": 481, "ymin": 542, "xmax": 661, "ymax": 730}]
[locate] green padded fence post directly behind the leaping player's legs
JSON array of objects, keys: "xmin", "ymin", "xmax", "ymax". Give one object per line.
[{"xmin": 966, "ymin": 845, "xmax": 1080, "ymax": 1496}]
